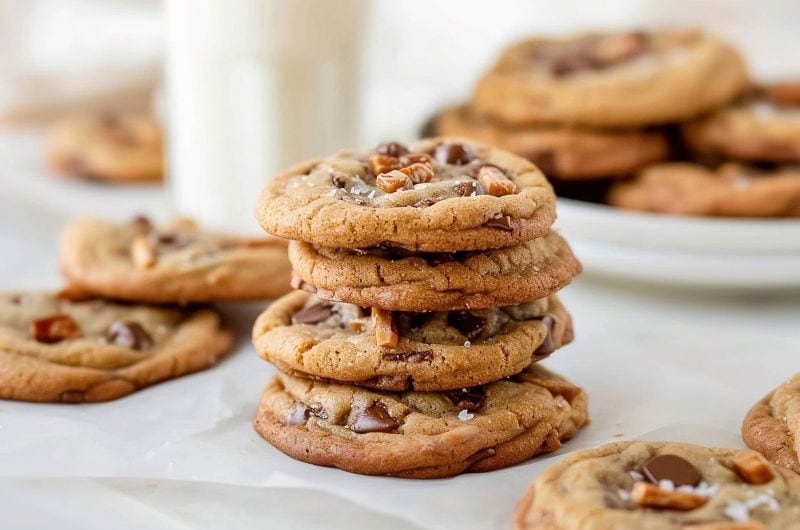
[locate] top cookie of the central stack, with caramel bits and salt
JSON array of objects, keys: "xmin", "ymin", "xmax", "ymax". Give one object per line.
[{"xmin": 256, "ymin": 138, "xmax": 555, "ymax": 252}]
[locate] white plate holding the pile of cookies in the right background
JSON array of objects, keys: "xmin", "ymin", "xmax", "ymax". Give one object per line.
[{"xmin": 556, "ymin": 199, "xmax": 800, "ymax": 289}]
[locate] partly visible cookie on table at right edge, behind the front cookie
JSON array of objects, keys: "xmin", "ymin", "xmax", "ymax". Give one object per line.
[{"xmin": 742, "ymin": 373, "xmax": 800, "ymax": 473}]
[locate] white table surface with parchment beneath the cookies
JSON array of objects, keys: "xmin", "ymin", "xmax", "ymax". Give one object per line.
[{"xmin": 0, "ymin": 132, "xmax": 800, "ymax": 530}]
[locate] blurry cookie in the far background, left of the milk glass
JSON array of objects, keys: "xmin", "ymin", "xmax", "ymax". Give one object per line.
[{"xmin": 46, "ymin": 113, "xmax": 164, "ymax": 183}]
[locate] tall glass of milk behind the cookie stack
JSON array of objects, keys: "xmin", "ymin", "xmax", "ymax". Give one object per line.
[{"xmin": 166, "ymin": 0, "xmax": 368, "ymax": 232}]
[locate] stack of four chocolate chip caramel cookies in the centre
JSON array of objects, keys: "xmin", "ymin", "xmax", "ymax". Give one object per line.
[{"xmin": 253, "ymin": 138, "xmax": 587, "ymax": 478}]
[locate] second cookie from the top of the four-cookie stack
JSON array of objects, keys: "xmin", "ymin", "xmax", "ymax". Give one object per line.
[{"xmin": 289, "ymin": 232, "xmax": 581, "ymax": 311}]
